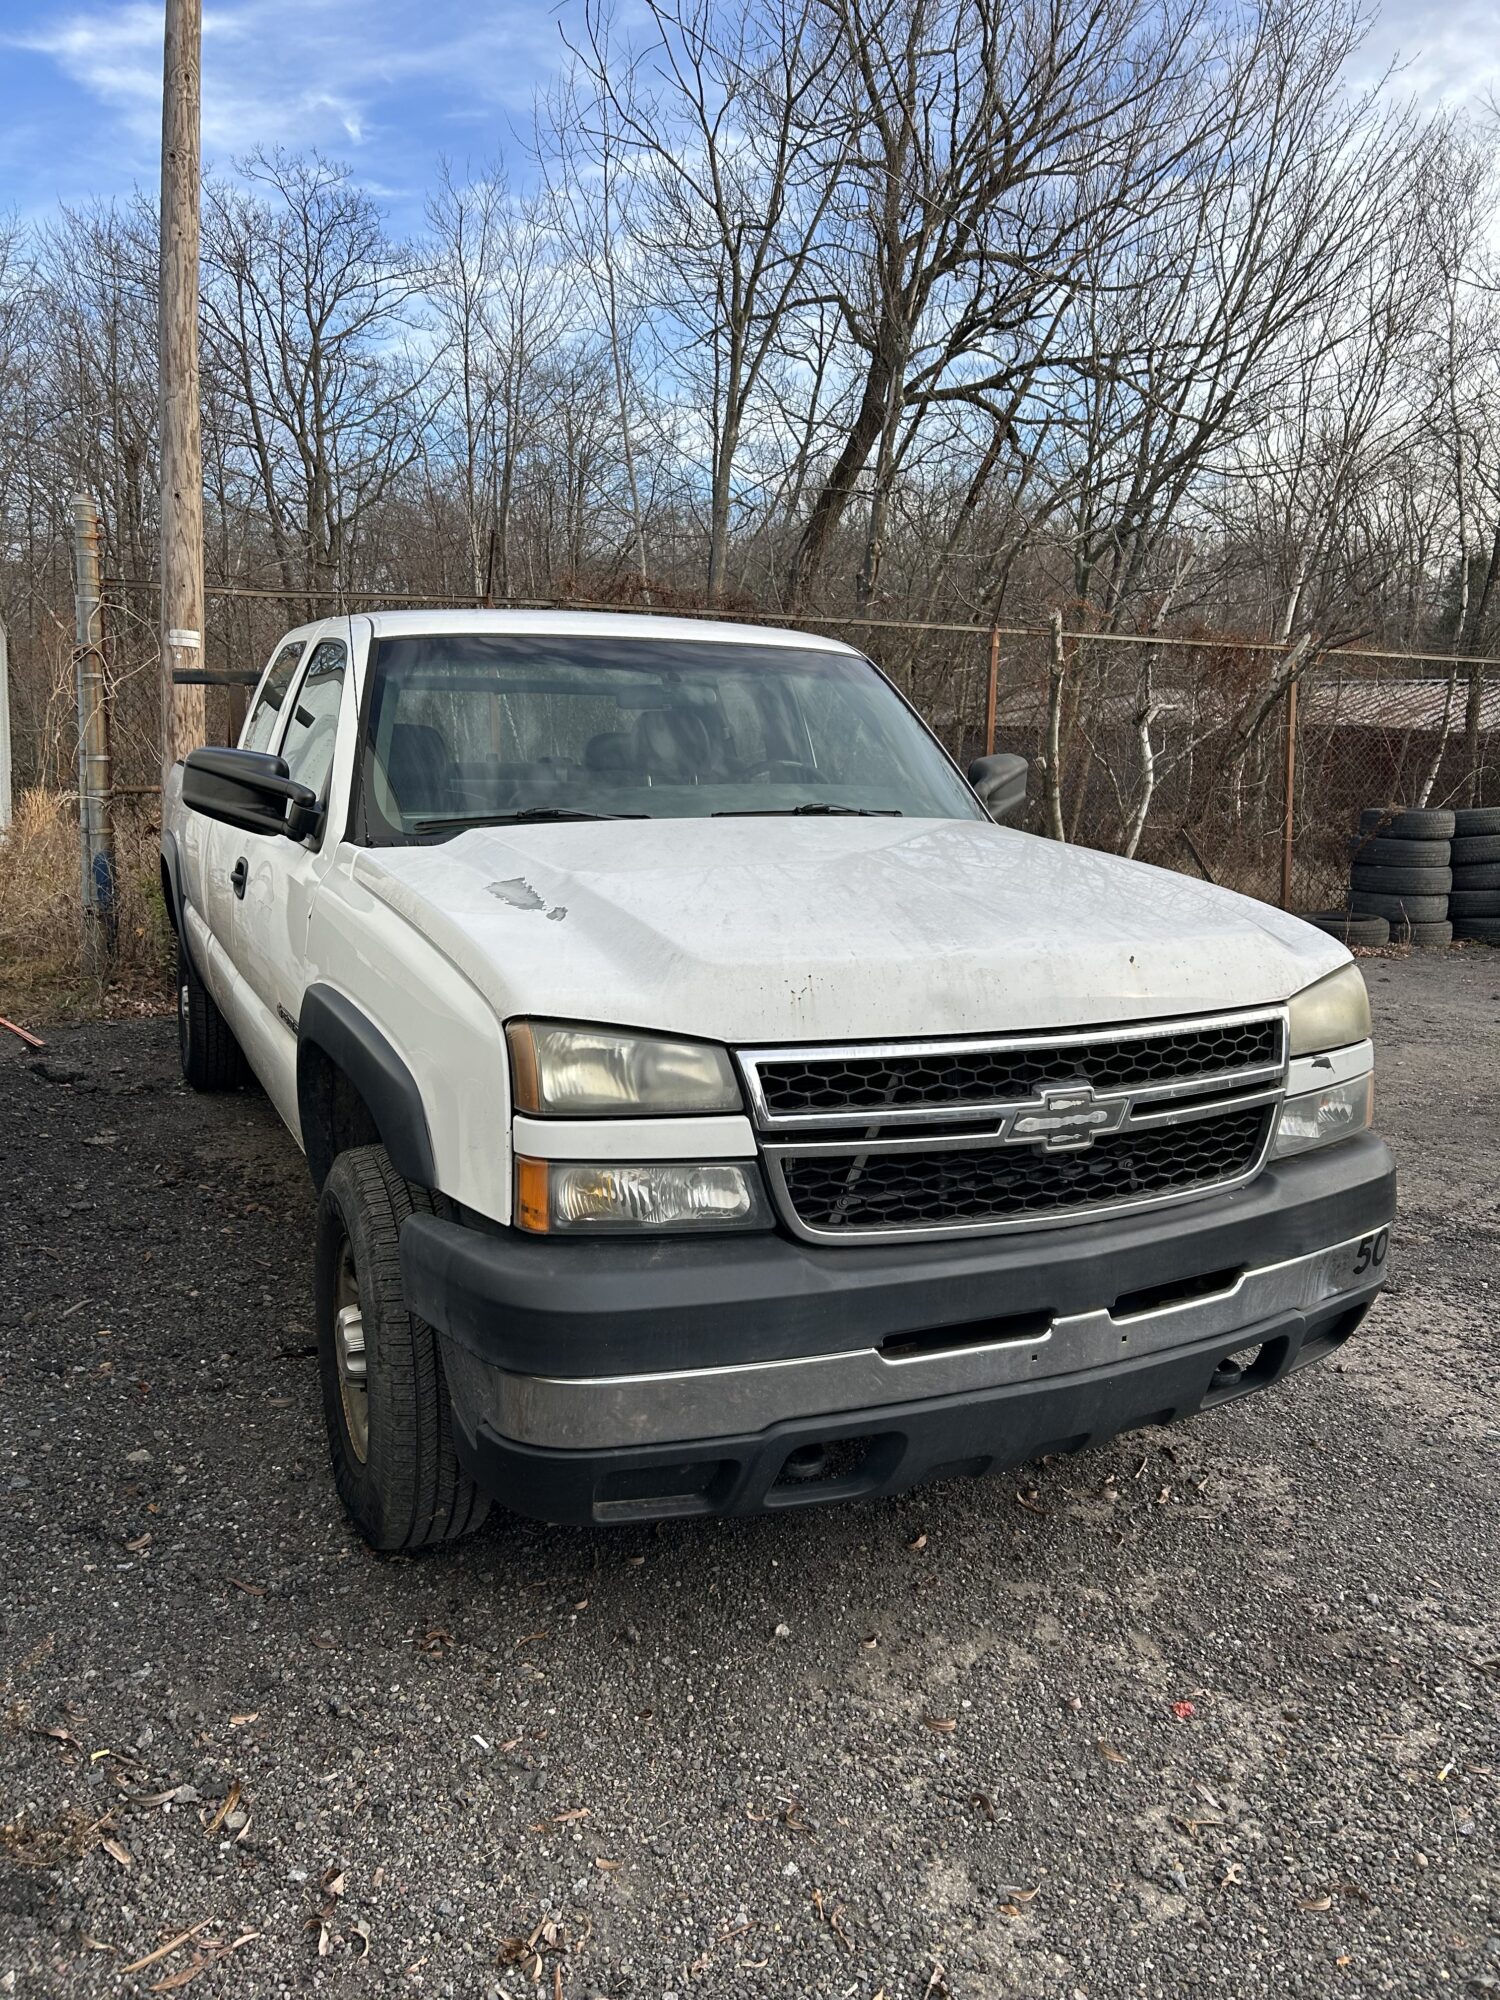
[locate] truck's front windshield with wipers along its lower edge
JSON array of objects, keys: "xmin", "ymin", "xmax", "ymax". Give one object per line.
[{"xmin": 362, "ymin": 632, "xmax": 984, "ymax": 842}]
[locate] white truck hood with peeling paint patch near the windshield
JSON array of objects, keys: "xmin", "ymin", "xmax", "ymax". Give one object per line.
[{"xmin": 352, "ymin": 818, "xmax": 1348, "ymax": 1044}]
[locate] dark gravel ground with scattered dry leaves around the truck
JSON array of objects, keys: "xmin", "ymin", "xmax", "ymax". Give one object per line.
[{"xmin": 0, "ymin": 950, "xmax": 1500, "ymax": 2000}]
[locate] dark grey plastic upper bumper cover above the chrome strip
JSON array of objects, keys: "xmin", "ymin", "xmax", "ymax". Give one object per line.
[{"xmin": 402, "ymin": 1134, "xmax": 1396, "ymax": 1376}]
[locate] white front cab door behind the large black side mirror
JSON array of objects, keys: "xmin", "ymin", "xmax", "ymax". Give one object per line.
[{"xmin": 228, "ymin": 620, "xmax": 358, "ymax": 1132}]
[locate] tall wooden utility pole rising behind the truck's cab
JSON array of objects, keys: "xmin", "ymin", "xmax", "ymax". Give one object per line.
[{"xmin": 158, "ymin": 0, "xmax": 206, "ymax": 784}]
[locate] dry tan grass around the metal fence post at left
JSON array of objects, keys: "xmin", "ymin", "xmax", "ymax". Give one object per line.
[{"xmin": 0, "ymin": 788, "xmax": 170, "ymax": 1026}]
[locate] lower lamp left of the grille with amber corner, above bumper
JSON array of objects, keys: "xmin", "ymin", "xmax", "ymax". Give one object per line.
[{"xmin": 516, "ymin": 1158, "xmax": 772, "ymax": 1234}]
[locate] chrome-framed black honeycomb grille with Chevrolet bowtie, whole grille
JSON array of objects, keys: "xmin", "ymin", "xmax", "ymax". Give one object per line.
[{"xmin": 740, "ymin": 1008, "xmax": 1286, "ymax": 1242}]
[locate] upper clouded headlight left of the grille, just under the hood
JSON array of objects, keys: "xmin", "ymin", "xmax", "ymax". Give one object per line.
[{"xmin": 506, "ymin": 1020, "xmax": 740, "ymax": 1118}]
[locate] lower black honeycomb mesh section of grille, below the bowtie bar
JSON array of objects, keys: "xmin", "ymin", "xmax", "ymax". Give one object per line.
[{"xmin": 782, "ymin": 1106, "xmax": 1272, "ymax": 1234}]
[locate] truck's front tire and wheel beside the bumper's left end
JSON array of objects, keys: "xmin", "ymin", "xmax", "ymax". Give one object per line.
[{"xmin": 314, "ymin": 1146, "xmax": 490, "ymax": 1552}]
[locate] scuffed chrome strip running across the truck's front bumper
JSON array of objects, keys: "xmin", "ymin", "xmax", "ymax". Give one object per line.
[{"xmin": 444, "ymin": 1238, "xmax": 1384, "ymax": 1450}]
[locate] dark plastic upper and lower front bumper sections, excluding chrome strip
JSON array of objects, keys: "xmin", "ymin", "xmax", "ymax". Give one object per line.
[{"xmin": 402, "ymin": 1134, "xmax": 1396, "ymax": 1522}]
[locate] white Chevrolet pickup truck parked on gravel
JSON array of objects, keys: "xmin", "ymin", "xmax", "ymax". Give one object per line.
[{"xmin": 162, "ymin": 612, "xmax": 1396, "ymax": 1550}]
